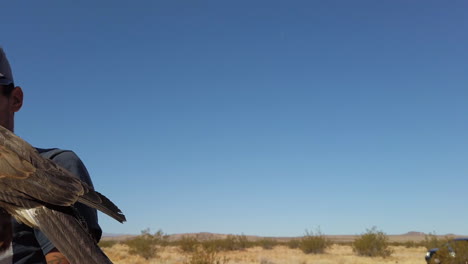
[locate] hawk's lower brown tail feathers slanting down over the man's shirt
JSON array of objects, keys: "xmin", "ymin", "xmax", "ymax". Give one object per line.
[{"xmin": 35, "ymin": 207, "xmax": 112, "ymax": 264}]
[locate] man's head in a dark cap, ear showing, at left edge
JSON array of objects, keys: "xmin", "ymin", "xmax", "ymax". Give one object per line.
[{"xmin": 0, "ymin": 48, "xmax": 23, "ymax": 131}]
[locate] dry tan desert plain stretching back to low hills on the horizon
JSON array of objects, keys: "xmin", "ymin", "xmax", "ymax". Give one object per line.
[{"xmin": 101, "ymin": 230, "xmax": 458, "ymax": 264}]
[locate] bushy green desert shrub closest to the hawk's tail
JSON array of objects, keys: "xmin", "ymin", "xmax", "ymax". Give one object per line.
[{"xmin": 124, "ymin": 229, "xmax": 167, "ymax": 259}]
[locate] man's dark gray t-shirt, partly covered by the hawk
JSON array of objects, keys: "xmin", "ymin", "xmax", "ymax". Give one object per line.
[{"xmin": 0, "ymin": 148, "xmax": 102, "ymax": 264}]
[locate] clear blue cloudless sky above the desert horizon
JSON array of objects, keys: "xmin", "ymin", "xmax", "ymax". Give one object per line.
[{"xmin": 0, "ymin": 0, "xmax": 468, "ymax": 236}]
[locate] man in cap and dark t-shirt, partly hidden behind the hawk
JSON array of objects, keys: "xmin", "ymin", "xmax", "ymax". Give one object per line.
[{"xmin": 0, "ymin": 47, "xmax": 102, "ymax": 264}]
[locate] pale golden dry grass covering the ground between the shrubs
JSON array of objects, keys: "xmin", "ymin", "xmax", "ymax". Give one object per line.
[{"xmin": 104, "ymin": 244, "xmax": 426, "ymax": 264}]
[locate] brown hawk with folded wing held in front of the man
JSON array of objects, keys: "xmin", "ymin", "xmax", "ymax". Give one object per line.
[{"xmin": 0, "ymin": 126, "xmax": 126, "ymax": 264}]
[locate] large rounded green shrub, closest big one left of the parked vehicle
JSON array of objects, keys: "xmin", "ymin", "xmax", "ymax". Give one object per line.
[{"xmin": 353, "ymin": 227, "xmax": 393, "ymax": 257}]
